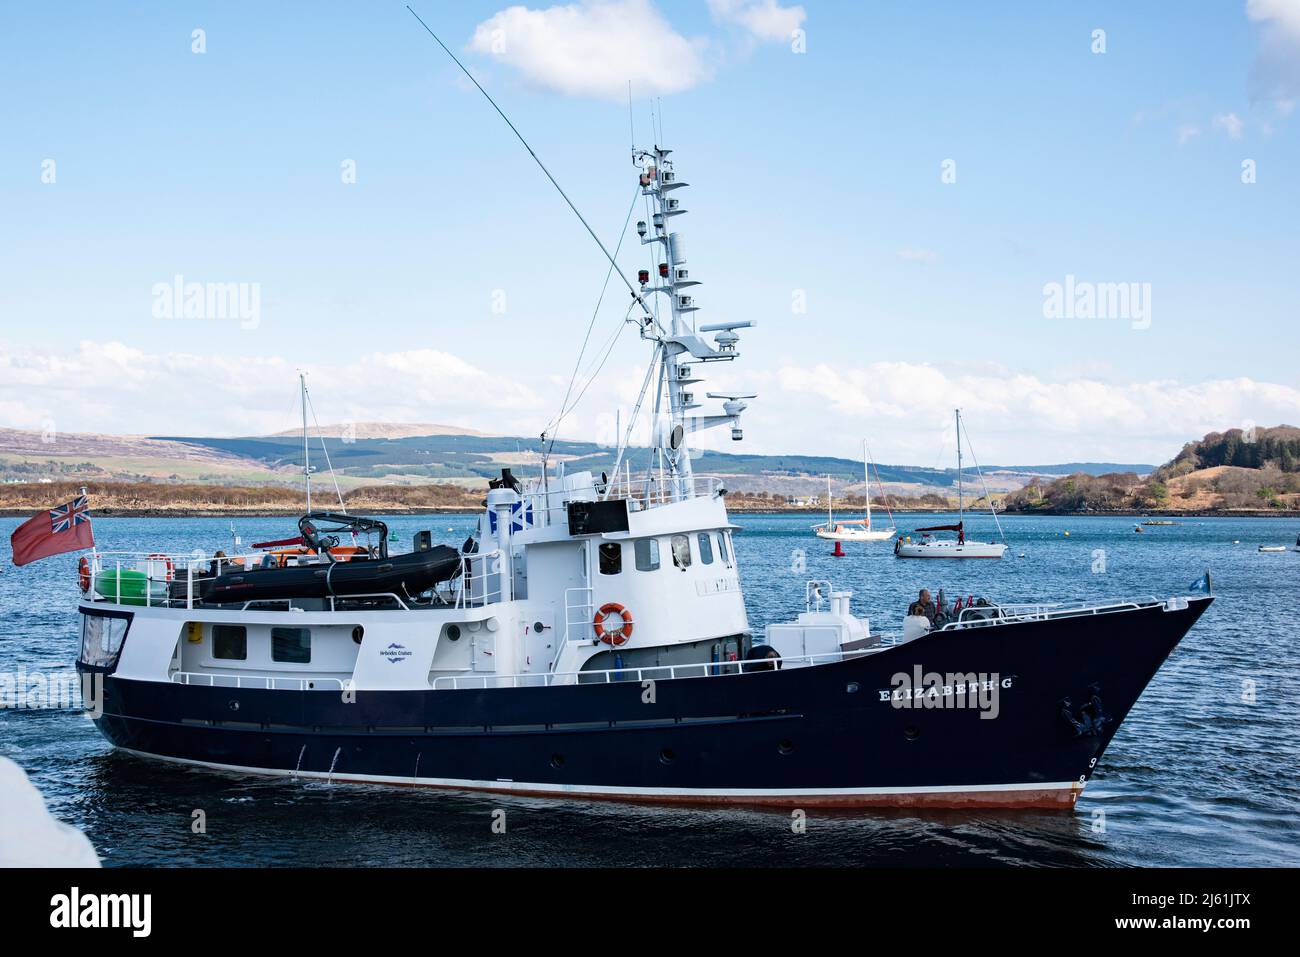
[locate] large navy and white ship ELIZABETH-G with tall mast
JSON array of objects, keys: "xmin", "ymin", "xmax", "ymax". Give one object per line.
[{"xmin": 69, "ymin": 42, "xmax": 1213, "ymax": 809}]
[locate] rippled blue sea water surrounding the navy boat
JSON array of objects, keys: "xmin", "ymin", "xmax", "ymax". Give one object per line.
[{"xmin": 0, "ymin": 515, "xmax": 1300, "ymax": 866}]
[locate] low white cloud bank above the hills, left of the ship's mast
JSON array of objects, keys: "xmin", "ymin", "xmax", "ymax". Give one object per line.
[{"xmin": 0, "ymin": 341, "xmax": 549, "ymax": 436}]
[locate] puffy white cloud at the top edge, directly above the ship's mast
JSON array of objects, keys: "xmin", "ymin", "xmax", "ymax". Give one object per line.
[{"xmin": 469, "ymin": 0, "xmax": 710, "ymax": 101}]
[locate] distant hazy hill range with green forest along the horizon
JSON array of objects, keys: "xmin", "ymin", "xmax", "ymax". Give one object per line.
[{"xmin": 0, "ymin": 423, "xmax": 1152, "ymax": 501}]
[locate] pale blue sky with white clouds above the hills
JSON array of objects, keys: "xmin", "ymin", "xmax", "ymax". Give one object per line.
[{"xmin": 0, "ymin": 0, "xmax": 1300, "ymax": 465}]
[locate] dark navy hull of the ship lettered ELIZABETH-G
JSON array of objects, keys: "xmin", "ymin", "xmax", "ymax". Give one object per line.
[{"xmin": 86, "ymin": 598, "xmax": 1210, "ymax": 806}]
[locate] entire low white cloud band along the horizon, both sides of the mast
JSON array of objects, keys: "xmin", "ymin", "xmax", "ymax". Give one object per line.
[{"xmin": 10, "ymin": 341, "xmax": 1300, "ymax": 467}]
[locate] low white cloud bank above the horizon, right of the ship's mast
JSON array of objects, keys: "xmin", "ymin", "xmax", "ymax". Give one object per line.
[{"xmin": 746, "ymin": 361, "xmax": 1300, "ymax": 465}]
